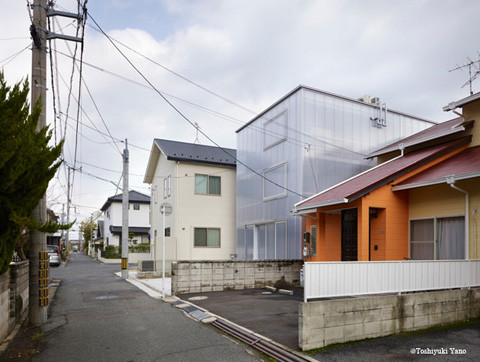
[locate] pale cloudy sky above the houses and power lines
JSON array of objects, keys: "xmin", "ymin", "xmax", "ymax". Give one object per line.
[{"xmin": 0, "ymin": 0, "xmax": 480, "ymax": 226}]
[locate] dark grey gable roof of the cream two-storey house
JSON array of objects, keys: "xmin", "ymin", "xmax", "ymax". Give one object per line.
[{"xmin": 143, "ymin": 138, "xmax": 237, "ymax": 183}]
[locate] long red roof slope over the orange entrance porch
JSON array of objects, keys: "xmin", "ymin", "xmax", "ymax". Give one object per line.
[{"xmin": 292, "ymin": 136, "xmax": 471, "ymax": 213}]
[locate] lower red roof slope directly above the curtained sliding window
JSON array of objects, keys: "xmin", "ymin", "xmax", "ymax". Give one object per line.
[{"xmin": 395, "ymin": 146, "xmax": 480, "ymax": 190}]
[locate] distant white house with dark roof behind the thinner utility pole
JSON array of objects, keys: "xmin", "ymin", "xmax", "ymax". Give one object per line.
[{"xmin": 101, "ymin": 191, "xmax": 150, "ymax": 246}]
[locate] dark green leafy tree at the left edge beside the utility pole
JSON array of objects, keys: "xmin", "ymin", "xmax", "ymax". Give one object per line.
[{"xmin": 0, "ymin": 72, "xmax": 63, "ymax": 275}]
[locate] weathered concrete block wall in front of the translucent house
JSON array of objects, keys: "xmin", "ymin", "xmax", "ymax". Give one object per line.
[{"xmin": 172, "ymin": 260, "xmax": 303, "ymax": 294}]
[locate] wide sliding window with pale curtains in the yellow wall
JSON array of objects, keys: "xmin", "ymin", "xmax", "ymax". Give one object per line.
[{"xmin": 410, "ymin": 216, "xmax": 465, "ymax": 260}]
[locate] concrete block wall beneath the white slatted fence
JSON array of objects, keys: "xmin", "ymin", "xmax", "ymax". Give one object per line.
[{"xmin": 299, "ymin": 288, "xmax": 480, "ymax": 351}]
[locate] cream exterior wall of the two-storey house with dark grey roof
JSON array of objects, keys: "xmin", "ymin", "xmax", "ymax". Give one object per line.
[{"xmin": 150, "ymin": 150, "xmax": 236, "ymax": 261}]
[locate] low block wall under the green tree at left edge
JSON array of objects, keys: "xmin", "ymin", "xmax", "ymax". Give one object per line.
[{"xmin": 0, "ymin": 261, "xmax": 29, "ymax": 343}]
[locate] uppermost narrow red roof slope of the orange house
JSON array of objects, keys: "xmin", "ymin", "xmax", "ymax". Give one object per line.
[{"xmin": 367, "ymin": 117, "xmax": 471, "ymax": 158}]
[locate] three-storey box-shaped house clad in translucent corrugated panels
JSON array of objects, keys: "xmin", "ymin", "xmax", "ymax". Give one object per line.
[{"xmin": 237, "ymin": 86, "xmax": 435, "ymax": 260}]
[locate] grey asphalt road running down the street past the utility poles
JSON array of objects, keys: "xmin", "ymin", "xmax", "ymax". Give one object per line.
[{"xmin": 32, "ymin": 253, "xmax": 261, "ymax": 362}]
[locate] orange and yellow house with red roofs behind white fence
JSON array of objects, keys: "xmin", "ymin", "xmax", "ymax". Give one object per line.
[{"xmin": 292, "ymin": 93, "xmax": 480, "ymax": 261}]
